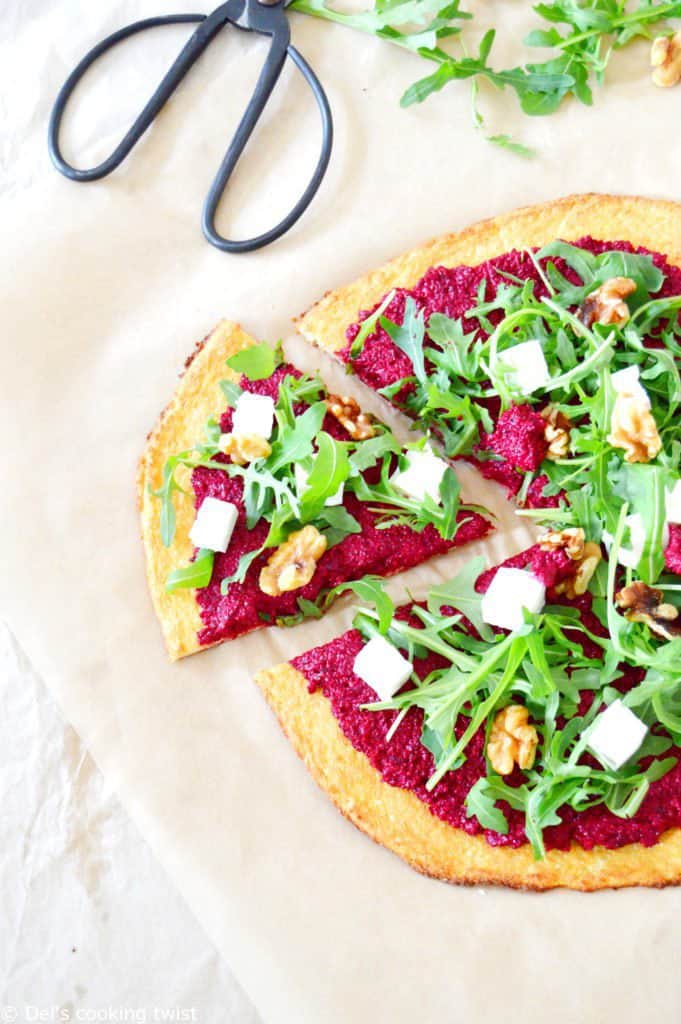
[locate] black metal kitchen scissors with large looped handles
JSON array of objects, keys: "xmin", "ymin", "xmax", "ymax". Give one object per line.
[{"xmin": 48, "ymin": 0, "xmax": 333, "ymax": 253}]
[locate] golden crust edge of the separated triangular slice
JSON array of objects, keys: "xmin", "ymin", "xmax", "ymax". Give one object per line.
[{"xmin": 137, "ymin": 321, "xmax": 255, "ymax": 660}]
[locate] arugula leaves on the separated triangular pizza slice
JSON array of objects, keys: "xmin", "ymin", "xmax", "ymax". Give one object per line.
[{"xmin": 154, "ymin": 345, "xmax": 472, "ymax": 598}]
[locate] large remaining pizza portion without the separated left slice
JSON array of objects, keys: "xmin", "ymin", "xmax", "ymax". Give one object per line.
[{"xmin": 250, "ymin": 196, "xmax": 681, "ymax": 890}]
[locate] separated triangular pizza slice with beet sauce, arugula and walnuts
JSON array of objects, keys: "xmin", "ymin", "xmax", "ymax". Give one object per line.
[{"xmin": 139, "ymin": 322, "xmax": 491, "ymax": 658}]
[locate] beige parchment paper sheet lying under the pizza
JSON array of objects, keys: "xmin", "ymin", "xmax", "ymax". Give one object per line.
[{"xmin": 0, "ymin": 0, "xmax": 681, "ymax": 1024}]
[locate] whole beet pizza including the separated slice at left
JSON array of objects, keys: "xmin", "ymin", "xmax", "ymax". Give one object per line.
[{"xmin": 140, "ymin": 196, "xmax": 681, "ymax": 891}]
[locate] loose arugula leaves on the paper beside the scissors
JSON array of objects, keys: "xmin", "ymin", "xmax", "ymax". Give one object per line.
[{"xmin": 292, "ymin": 0, "xmax": 681, "ymax": 156}]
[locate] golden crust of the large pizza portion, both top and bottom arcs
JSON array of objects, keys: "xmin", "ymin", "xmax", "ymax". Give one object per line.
[{"xmin": 284, "ymin": 195, "xmax": 681, "ymax": 891}]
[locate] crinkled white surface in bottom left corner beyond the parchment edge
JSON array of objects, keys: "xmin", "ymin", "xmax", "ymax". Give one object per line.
[{"xmin": 0, "ymin": 627, "xmax": 259, "ymax": 1024}]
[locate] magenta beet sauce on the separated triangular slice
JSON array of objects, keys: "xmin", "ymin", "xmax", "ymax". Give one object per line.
[{"xmin": 191, "ymin": 366, "xmax": 491, "ymax": 644}]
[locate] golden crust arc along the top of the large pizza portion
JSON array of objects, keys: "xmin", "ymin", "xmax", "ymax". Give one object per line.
[{"xmin": 296, "ymin": 195, "xmax": 681, "ymax": 352}]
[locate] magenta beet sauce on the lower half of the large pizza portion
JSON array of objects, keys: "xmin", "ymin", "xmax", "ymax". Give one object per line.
[{"xmin": 291, "ymin": 547, "xmax": 681, "ymax": 850}]
